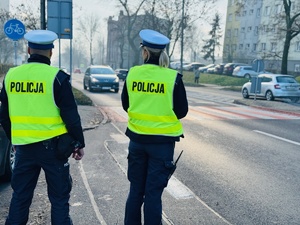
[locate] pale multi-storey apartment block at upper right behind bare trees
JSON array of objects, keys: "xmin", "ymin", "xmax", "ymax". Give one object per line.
[{"xmin": 223, "ymin": 0, "xmax": 300, "ymax": 73}]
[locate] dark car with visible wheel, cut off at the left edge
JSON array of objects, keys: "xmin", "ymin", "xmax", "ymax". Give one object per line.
[{"xmin": 0, "ymin": 107, "xmax": 15, "ymax": 180}]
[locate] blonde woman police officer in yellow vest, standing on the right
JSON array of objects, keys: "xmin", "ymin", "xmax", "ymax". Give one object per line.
[{"xmin": 121, "ymin": 29, "xmax": 188, "ymax": 225}]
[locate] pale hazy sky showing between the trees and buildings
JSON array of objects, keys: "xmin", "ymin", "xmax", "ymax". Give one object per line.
[{"xmin": 8, "ymin": 0, "xmax": 228, "ymax": 64}]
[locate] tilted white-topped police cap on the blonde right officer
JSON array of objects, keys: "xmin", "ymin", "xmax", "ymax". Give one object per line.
[{"xmin": 139, "ymin": 29, "xmax": 170, "ymax": 49}]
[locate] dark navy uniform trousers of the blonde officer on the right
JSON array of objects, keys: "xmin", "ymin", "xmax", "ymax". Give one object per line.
[{"xmin": 125, "ymin": 141, "xmax": 175, "ymax": 225}]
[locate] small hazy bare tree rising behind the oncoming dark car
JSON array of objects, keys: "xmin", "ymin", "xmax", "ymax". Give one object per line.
[{"xmin": 78, "ymin": 14, "xmax": 100, "ymax": 65}]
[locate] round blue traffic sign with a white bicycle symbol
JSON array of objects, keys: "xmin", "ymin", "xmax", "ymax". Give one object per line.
[{"xmin": 4, "ymin": 19, "xmax": 25, "ymax": 41}]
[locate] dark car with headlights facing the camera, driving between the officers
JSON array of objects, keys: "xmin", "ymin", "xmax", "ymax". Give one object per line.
[{"xmin": 83, "ymin": 65, "xmax": 119, "ymax": 93}]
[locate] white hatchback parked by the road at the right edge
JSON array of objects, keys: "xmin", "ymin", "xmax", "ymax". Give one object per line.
[{"xmin": 242, "ymin": 73, "xmax": 300, "ymax": 102}]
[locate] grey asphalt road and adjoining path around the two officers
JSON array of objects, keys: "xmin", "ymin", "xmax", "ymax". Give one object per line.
[{"xmin": 0, "ymin": 75, "xmax": 300, "ymax": 225}]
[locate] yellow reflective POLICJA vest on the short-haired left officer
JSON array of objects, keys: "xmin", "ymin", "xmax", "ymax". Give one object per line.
[{"xmin": 5, "ymin": 63, "xmax": 67, "ymax": 145}]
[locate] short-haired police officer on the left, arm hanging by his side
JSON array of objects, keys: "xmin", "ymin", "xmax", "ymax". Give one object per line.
[{"xmin": 0, "ymin": 30, "xmax": 85, "ymax": 225}]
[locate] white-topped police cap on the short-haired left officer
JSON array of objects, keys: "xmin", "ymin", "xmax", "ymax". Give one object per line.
[{"xmin": 24, "ymin": 30, "xmax": 58, "ymax": 50}]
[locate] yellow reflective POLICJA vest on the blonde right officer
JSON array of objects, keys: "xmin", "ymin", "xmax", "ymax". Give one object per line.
[{"xmin": 126, "ymin": 64, "xmax": 183, "ymax": 137}]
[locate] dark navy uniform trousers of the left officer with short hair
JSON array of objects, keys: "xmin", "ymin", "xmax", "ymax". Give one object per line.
[{"xmin": 5, "ymin": 138, "xmax": 73, "ymax": 225}]
